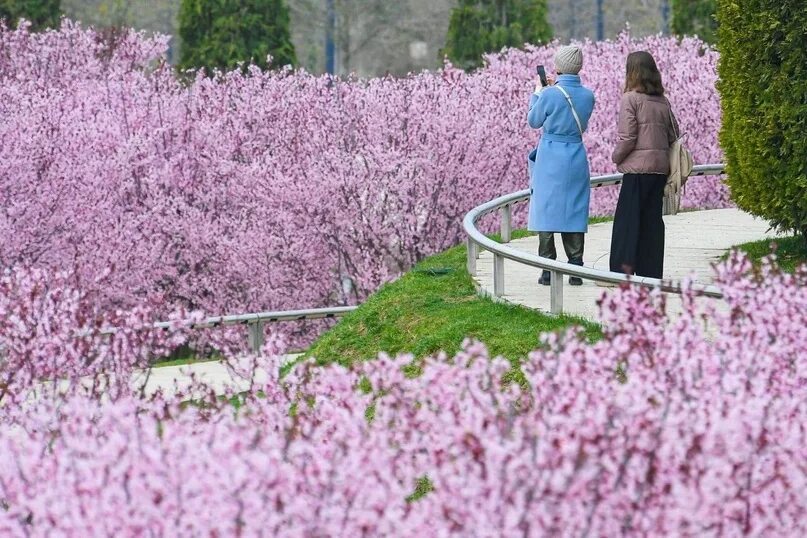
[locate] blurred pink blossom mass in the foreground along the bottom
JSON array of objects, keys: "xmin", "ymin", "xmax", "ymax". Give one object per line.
[{"xmin": 0, "ymin": 253, "xmax": 807, "ymax": 538}]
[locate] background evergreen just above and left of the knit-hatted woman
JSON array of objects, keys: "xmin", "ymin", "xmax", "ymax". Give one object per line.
[{"xmin": 443, "ymin": 0, "xmax": 552, "ymax": 69}]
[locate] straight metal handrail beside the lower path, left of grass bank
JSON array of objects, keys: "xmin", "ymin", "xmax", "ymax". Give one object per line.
[{"xmin": 100, "ymin": 306, "xmax": 358, "ymax": 352}]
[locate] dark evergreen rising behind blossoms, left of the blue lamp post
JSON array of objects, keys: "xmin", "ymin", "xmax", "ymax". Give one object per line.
[{"xmin": 179, "ymin": 0, "xmax": 296, "ymax": 69}]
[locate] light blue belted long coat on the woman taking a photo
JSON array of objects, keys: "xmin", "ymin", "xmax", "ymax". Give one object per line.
[{"xmin": 527, "ymin": 75, "xmax": 594, "ymax": 232}]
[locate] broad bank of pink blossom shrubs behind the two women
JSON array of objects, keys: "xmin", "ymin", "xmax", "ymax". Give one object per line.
[{"xmin": 0, "ymin": 21, "xmax": 728, "ymax": 342}]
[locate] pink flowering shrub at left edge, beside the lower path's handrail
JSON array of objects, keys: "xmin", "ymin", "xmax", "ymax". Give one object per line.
[{"xmin": 0, "ymin": 269, "xmax": 184, "ymax": 405}]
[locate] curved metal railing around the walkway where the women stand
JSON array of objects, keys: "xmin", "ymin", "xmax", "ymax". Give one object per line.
[{"xmin": 462, "ymin": 164, "xmax": 725, "ymax": 314}]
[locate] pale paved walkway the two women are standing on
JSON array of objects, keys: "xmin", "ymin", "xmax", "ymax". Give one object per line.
[{"xmin": 475, "ymin": 209, "xmax": 776, "ymax": 320}]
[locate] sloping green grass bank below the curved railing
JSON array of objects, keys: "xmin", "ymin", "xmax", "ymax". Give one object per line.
[{"xmin": 303, "ymin": 231, "xmax": 601, "ymax": 365}]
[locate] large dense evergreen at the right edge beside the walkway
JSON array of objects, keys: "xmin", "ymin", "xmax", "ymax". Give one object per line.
[{"xmin": 717, "ymin": 0, "xmax": 807, "ymax": 246}]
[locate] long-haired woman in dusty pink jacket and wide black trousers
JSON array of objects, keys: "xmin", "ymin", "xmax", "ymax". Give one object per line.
[{"xmin": 610, "ymin": 51, "xmax": 678, "ymax": 278}]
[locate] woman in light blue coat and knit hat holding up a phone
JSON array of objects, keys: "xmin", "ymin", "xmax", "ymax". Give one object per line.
[{"xmin": 527, "ymin": 45, "xmax": 594, "ymax": 286}]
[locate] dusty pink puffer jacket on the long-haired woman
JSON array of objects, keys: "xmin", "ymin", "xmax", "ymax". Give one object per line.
[{"xmin": 611, "ymin": 91, "xmax": 678, "ymax": 175}]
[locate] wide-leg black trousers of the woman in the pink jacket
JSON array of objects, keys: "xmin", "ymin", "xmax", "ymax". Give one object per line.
[{"xmin": 611, "ymin": 174, "xmax": 667, "ymax": 278}]
